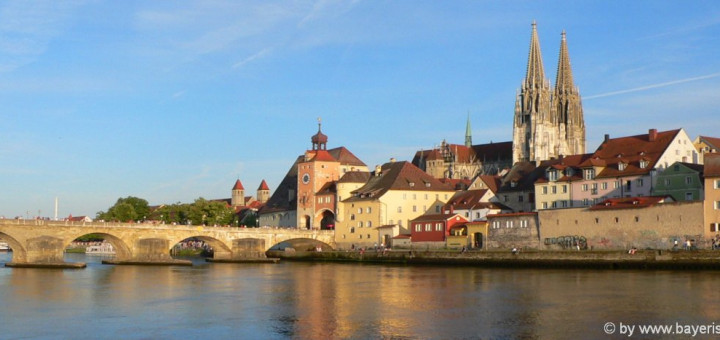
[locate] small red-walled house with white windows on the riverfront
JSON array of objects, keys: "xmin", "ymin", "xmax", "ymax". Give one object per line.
[{"xmin": 410, "ymin": 214, "xmax": 468, "ymax": 247}]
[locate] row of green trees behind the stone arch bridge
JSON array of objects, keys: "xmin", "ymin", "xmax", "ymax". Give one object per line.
[{"xmin": 91, "ymin": 196, "xmax": 257, "ymax": 227}]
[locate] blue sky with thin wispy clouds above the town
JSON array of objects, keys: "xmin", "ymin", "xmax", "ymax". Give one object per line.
[{"xmin": 0, "ymin": 1, "xmax": 720, "ymax": 218}]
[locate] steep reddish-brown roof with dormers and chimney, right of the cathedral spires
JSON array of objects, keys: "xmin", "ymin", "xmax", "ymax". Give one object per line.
[{"xmin": 593, "ymin": 129, "xmax": 680, "ymax": 178}]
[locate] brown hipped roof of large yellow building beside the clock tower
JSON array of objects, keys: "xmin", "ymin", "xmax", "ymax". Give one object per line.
[{"xmin": 347, "ymin": 161, "xmax": 453, "ymax": 201}]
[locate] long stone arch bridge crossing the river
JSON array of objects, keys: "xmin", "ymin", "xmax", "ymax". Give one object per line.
[{"xmin": 0, "ymin": 219, "xmax": 335, "ymax": 266}]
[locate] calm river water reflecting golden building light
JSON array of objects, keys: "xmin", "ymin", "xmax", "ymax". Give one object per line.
[{"xmin": 0, "ymin": 253, "xmax": 720, "ymax": 339}]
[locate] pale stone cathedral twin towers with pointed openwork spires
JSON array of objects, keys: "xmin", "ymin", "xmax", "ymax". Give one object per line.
[{"xmin": 513, "ymin": 22, "xmax": 585, "ymax": 163}]
